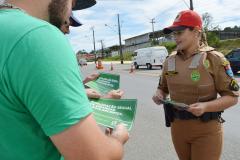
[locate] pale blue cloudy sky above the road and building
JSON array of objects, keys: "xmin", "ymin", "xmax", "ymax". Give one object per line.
[{"xmin": 68, "ymin": 0, "xmax": 240, "ymax": 51}]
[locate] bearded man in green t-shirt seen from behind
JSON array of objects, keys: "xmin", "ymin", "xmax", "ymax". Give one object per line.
[{"xmin": 0, "ymin": 0, "xmax": 128, "ymax": 160}]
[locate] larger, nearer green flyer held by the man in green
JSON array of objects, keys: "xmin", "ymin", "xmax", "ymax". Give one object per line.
[{"xmin": 90, "ymin": 99, "xmax": 137, "ymax": 130}]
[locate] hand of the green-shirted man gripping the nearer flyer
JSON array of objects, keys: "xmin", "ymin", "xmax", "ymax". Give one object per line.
[{"xmin": 109, "ymin": 124, "xmax": 129, "ymax": 144}]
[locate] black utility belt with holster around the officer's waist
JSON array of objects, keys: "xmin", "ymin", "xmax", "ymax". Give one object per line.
[{"xmin": 163, "ymin": 104, "xmax": 225, "ymax": 127}]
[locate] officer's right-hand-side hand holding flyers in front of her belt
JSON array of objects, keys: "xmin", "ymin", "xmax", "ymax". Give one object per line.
[{"xmin": 187, "ymin": 103, "xmax": 207, "ymax": 117}]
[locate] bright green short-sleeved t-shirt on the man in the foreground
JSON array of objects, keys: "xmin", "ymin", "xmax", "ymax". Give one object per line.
[{"xmin": 0, "ymin": 9, "xmax": 92, "ymax": 160}]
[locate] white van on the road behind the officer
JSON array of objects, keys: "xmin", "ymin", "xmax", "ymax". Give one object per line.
[{"xmin": 133, "ymin": 46, "xmax": 168, "ymax": 69}]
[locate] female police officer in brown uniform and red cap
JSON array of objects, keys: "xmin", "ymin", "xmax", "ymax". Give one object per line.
[{"xmin": 153, "ymin": 10, "xmax": 239, "ymax": 160}]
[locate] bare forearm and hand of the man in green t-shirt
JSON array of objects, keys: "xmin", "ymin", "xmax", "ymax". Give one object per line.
[{"xmin": 50, "ymin": 115, "xmax": 128, "ymax": 160}]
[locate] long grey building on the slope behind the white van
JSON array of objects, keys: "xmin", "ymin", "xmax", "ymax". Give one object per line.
[{"xmin": 123, "ymin": 30, "xmax": 173, "ymax": 52}]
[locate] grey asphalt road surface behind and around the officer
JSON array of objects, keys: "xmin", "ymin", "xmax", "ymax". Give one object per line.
[{"xmin": 81, "ymin": 64, "xmax": 240, "ymax": 160}]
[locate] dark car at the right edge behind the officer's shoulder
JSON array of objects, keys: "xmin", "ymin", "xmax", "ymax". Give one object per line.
[{"xmin": 225, "ymin": 48, "xmax": 240, "ymax": 74}]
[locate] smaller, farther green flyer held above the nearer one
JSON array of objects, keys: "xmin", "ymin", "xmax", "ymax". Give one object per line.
[{"xmin": 85, "ymin": 73, "xmax": 120, "ymax": 94}]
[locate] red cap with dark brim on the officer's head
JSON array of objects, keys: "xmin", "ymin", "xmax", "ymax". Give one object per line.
[{"xmin": 163, "ymin": 10, "xmax": 202, "ymax": 34}]
